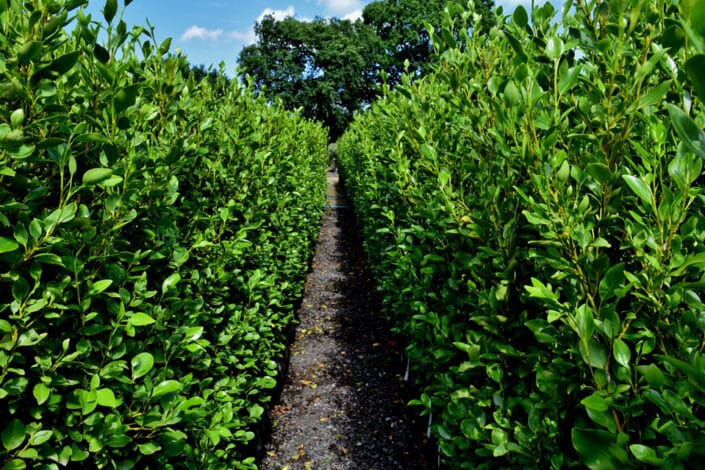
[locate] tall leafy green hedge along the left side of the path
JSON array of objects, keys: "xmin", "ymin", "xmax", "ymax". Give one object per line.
[{"xmin": 0, "ymin": 0, "xmax": 327, "ymax": 469}]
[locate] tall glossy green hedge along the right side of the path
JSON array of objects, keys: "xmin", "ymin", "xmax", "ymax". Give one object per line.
[{"xmin": 338, "ymin": 0, "xmax": 705, "ymax": 469}]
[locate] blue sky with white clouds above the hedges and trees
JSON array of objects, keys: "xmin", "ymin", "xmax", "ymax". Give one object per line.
[{"xmin": 82, "ymin": 0, "xmax": 531, "ymax": 76}]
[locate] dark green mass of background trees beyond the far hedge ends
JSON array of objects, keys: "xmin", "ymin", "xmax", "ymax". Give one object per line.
[{"xmin": 238, "ymin": 0, "xmax": 494, "ymax": 141}]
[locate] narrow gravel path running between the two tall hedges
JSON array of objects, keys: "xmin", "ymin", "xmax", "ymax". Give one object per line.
[{"xmin": 260, "ymin": 173, "xmax": 435, "ymax": 470}]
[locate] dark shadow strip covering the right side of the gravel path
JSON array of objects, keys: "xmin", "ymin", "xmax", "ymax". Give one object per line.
[{"xmin": 336, "ymin": 200, "xmax": 436, "ymax": 469}]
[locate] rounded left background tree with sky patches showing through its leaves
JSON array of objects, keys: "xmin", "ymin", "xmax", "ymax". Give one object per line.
[{"xmin": 239, "ymin": 16, "xmax": 380, "ymax": 140}]
